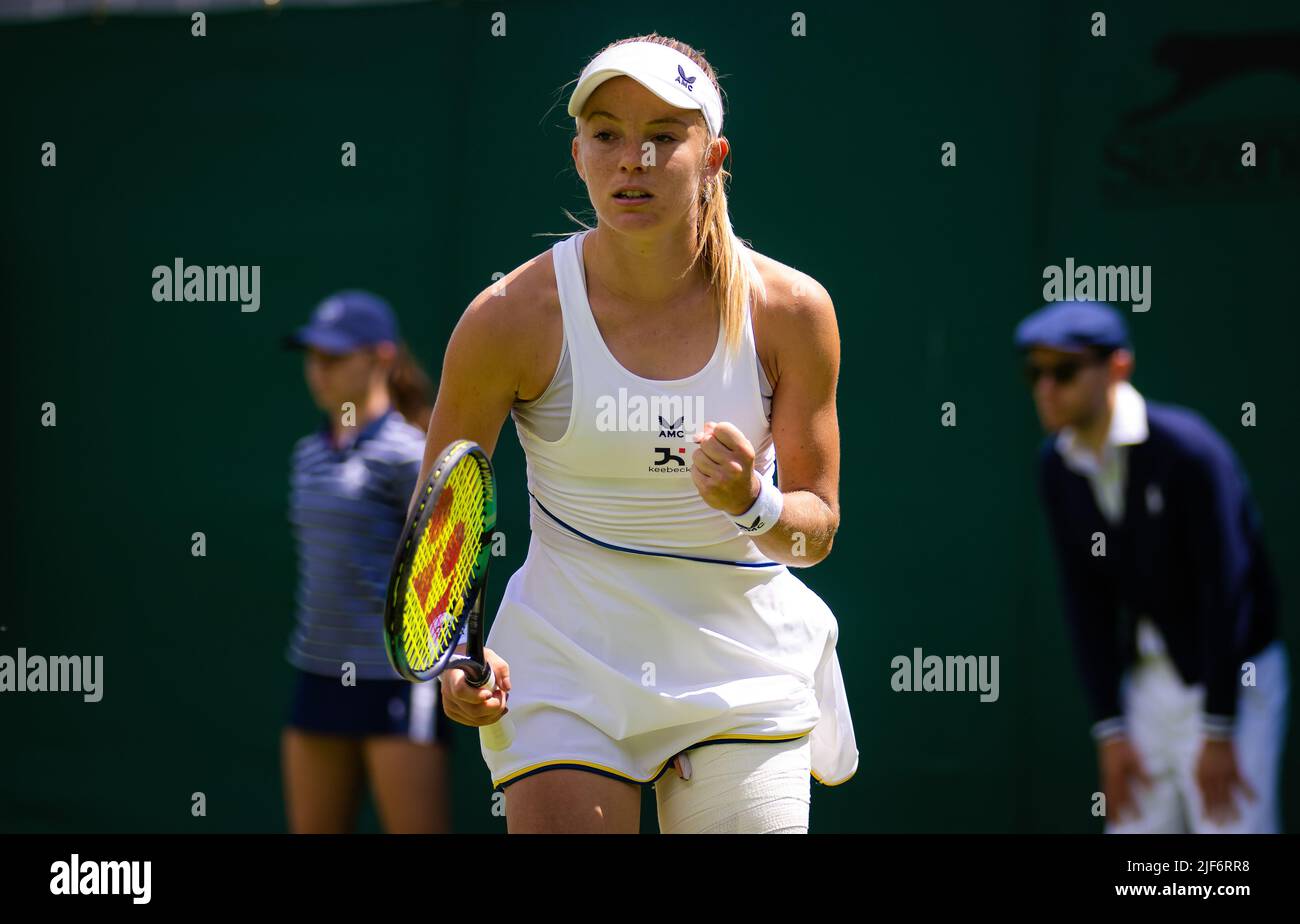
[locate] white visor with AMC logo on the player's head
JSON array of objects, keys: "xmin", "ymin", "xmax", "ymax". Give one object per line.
[{"xmin": 568, "ymin": 42, "xmax": 723, "ymax": 138}]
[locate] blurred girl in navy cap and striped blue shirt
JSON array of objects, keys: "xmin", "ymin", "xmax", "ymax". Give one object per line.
[{"xmin": 281, "ymin": 291, "xmax": 450, "ymax": 833}]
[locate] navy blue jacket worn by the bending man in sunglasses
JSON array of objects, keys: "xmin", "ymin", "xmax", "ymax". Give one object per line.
[{"xmin": 1039, "ymin": 402, "xmax": 1278, "ymax": 729}]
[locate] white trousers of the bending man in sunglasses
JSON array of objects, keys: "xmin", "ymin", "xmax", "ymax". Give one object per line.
[{"xmin": 1106, "ymin": 636, "xmax": 1288, "ymax": 834}]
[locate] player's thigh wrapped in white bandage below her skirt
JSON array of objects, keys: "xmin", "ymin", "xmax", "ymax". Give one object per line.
[{"xmin": 654, "ymin": 736, "xmax": 811, "ymax": 834}]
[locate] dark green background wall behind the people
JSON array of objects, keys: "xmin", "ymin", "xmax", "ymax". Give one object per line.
[{"xmin": 0, "ymin": 0, "xmax": 1300, "ymax": 832}]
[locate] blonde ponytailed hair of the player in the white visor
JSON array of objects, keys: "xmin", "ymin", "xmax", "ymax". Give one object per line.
[{"xmin": 566, "ymin": 32, "xmax": 767, "ymax": 363}]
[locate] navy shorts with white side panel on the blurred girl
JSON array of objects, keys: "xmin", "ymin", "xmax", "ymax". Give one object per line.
[{"xmin": 289, "ymin": 671, "xmax": 451, "ymax": 745}]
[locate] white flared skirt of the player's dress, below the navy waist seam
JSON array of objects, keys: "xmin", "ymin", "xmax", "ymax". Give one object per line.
[{"xmin": 482, "ymin": 520, "xmax": 858, "ymax": 789}]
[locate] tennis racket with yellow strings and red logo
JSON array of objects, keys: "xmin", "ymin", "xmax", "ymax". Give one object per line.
[{"xmin": 384, "ymin": 439, "xmax": 515, "ymax": 751}]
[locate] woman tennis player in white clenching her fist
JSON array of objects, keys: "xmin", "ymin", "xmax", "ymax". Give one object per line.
[{"xmin": 421, "ymin": 34, "xmax": 858, "ymax": 833}]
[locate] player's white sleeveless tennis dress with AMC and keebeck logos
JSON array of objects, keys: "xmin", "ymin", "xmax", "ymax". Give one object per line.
[{"xmin": 481, "ymin": 231, "xmax": 858, "ymax": 789}]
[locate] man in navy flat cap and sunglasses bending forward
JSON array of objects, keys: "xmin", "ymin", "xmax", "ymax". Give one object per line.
[{"xmin": 1015, "ymin": 302, "xmax": 1288, "ymax": 833}]
